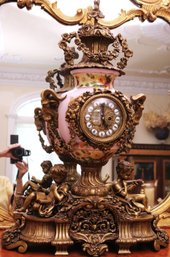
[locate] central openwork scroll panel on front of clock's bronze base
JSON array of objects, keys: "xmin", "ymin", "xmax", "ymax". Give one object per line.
[{"xmin": 70, "ymin": 198, "xmax": 118, "ymax": 256}]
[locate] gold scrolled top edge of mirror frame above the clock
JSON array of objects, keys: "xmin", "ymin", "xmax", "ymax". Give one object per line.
[{"xmin": 0, "ymin": 0, "xmax": 170, "ymax": 24}]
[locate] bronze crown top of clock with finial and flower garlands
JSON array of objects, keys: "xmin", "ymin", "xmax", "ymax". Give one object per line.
[{"xmin": 59, "ymin": 0, "xmax": 133, "ymax": 74}]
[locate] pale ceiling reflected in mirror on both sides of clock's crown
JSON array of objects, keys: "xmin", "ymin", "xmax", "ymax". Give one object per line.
[{"xmin": 0, "ymin": 3, "xmax": 170, "ymax": 93}]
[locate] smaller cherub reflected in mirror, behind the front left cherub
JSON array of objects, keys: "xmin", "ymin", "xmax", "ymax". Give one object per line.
[{"xmin": 22, "ymin": 161, "xmax": 52, "ymax": 194}]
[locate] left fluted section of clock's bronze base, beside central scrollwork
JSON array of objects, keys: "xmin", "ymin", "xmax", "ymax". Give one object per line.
[{"xmin": 2, "ymin": 212, "xmax": 73, "ymax": 256}]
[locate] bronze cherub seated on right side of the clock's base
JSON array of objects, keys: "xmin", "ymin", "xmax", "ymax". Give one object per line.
[{"xmin": 112, "ymin": 160, "xmax": 148, "ymax": 210}]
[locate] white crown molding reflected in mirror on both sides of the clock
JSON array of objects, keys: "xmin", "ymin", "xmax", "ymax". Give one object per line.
[{"xmin": 0, "ymin": 71, "xmax": 170, "ymax": 94}]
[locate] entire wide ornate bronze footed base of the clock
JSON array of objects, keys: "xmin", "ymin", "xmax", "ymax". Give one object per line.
[{"xmin": 2, "ymin": 196, "xmax": 169, "ymax": 256}]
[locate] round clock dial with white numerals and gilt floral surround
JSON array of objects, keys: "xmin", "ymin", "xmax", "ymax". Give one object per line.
[{"xmin": 66, "ymin": 90, "xmax": 129, "ymax": 149}]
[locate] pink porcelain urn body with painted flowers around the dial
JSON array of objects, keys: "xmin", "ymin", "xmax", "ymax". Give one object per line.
[{"xmin": 58, "ymin": 68, "xmax": 119, "ymax": 159}]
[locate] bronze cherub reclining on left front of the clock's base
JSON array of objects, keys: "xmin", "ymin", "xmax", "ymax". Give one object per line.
[{"xmin": 18, "ymin": 164, "xmax": 69, "ymax": 217}]
